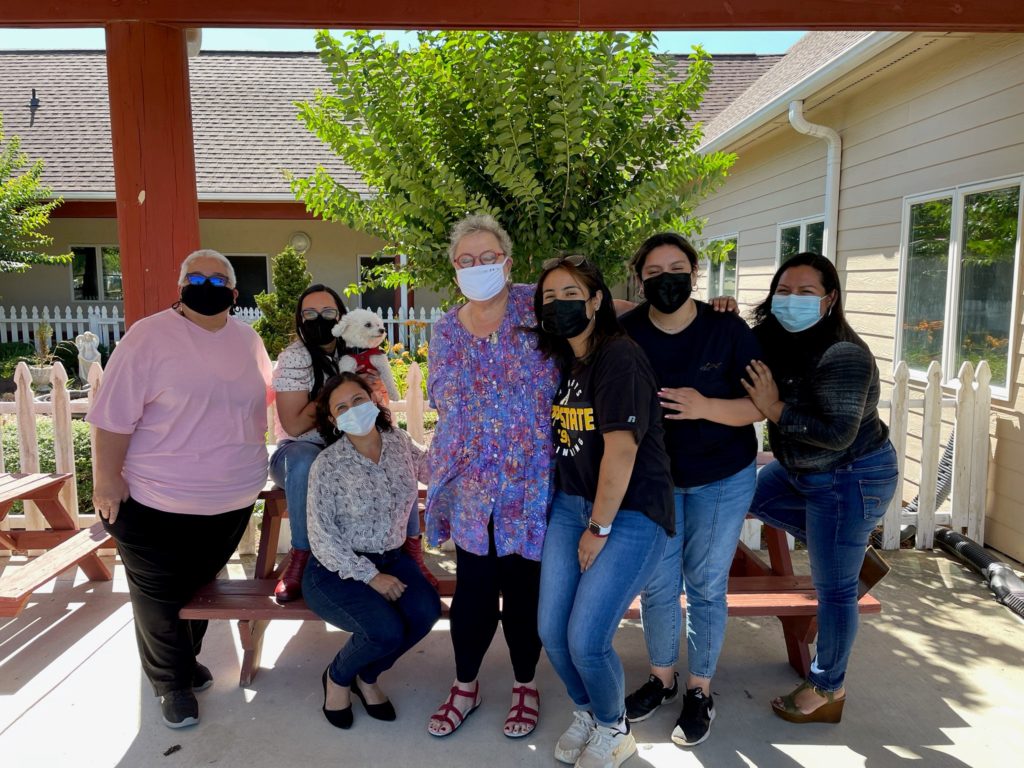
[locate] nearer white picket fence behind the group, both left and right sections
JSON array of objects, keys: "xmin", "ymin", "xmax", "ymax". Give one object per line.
[{"xmin": 0, "ymin": 361, "xmax": 991, "ymax": 554}]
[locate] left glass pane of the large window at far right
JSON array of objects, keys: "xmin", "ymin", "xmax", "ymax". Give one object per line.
[{"xmin": 900, "ymin": 198, "xmax": 952, "ymax": 371}]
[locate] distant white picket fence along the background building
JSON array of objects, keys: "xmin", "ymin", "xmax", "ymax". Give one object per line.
[{"xmin": 0, "ymin": 304, "xmax": 443, "ymax": 350}]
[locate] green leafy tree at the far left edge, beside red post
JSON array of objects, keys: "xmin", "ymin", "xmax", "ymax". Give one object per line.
[{"xmin": 0, "ymin": 115, "xmax": 71, "ymax": 273}]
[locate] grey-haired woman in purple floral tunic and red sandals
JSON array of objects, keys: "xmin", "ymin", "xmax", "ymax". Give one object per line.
[{"xmin": 427, "ymin": 216, "xmax": 558, "ymax": 738}]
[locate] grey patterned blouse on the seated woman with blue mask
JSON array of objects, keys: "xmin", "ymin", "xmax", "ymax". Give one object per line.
[{"xmin": 306, "ymin": 427, "xmax": 429, "ymax": 583}]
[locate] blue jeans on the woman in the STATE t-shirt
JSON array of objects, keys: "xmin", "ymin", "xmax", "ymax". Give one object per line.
[{"xmin": 538, "ymin": 492, "xmax": 668, "ymax": 726}]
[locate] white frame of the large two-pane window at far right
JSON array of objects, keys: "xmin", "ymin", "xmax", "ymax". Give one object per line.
[{"xmin": 893, "ymin": 175, "xmax": 1024, "ymax": 400}]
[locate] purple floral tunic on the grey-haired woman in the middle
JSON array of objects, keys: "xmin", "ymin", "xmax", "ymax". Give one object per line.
[{"xmin": 426, "ymin": 285, "xmax": 558, "ymax": 560}]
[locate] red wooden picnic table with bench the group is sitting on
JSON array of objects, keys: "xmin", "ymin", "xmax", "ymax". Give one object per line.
[{"xmin": 179, "ymin": 483, "xmax": 882, "ymax": 686}]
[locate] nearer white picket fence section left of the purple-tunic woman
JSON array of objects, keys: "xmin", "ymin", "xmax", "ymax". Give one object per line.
[{"xmin": 0, "ymin": 362, "xmax": 431, "ymax": 555}]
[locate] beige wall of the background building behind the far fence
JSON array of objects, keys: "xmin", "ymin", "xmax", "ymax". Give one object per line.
[{"xmin": 0, "ymin": 218, "xmax": 448, "ymax": 310}]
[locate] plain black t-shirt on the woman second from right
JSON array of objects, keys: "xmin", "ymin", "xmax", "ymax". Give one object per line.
[{"xmin": 621, "ymin": 301, "xmax": 762, "ymax": 488}]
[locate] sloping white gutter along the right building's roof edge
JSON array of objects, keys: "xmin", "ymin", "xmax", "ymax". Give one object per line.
[{"xmin": 699, "ymin": 32, "xmax": 912, "ymax": 153}]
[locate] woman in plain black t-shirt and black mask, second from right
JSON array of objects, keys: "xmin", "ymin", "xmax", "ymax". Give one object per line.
[{"xmin": 622, "ymin": 232, "xmax": 762, "ymax": 746}]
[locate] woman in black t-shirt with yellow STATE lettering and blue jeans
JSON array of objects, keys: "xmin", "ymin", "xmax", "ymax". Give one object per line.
[{"xmin": 535, "ymin": 256, "xmax": 674, "ymax": 766}]
